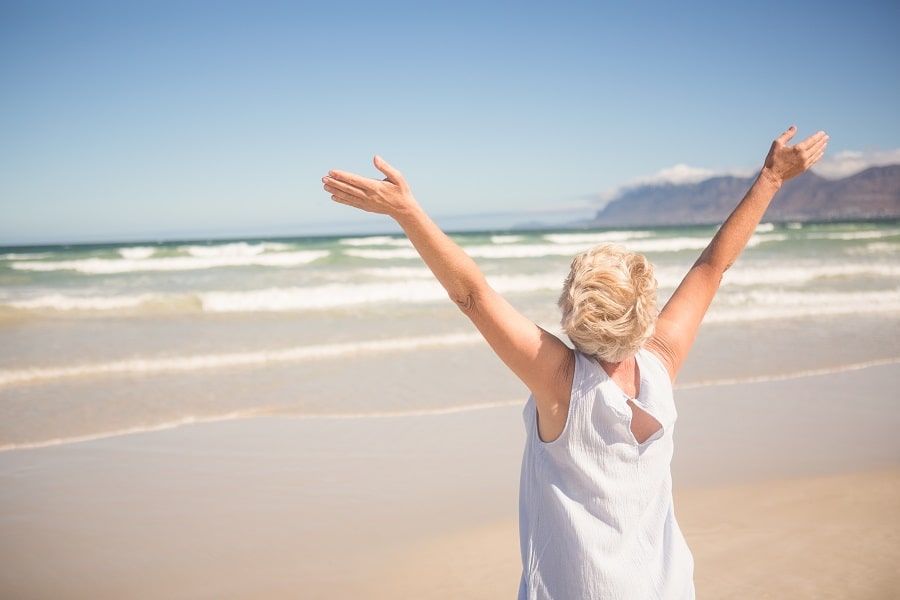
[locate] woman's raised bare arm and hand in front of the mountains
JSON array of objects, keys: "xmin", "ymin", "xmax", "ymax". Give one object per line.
[{"xmin": 647, "ymin": 126, "xmax": 828, "ymax": 381}]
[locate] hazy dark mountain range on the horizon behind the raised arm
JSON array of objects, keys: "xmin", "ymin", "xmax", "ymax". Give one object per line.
[{"xmin": 585, "ymin": 165, "xmax": 900, "ymax": 227}]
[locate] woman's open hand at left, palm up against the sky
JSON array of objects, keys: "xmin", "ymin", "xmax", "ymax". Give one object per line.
[{"xmin": 322, "ymin": 155, "xmax": 418, "ymax": 219}]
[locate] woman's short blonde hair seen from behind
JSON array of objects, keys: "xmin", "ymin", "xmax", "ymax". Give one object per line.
[{"xmin": 558, "ymin": 244, "xmax": 658, "ymax": 363}]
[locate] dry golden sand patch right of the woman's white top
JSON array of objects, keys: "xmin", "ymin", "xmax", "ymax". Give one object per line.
[{"xmin": 676, "ymin": 469, "xmax": 900, "ymax": 599}]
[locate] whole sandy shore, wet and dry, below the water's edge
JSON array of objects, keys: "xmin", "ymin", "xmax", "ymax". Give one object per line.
[{"xmin": 0, "ymin": 363, "xmax": 900, "ymax": 599}]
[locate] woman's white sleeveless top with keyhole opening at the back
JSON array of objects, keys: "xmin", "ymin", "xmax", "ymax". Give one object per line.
[{"xmin": 519, "ymin": 350, "xmax": 694, "ymax": 600}]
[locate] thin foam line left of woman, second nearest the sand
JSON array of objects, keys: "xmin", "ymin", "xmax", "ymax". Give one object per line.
[{"xmin": 0, "ymin": 333, "xmax": 482, "ymax": 387}]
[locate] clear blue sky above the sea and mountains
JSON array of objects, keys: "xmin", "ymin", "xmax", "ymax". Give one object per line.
[{"xmin": 0, "ymin": 0, "xmax": 900, "ymax": 246}]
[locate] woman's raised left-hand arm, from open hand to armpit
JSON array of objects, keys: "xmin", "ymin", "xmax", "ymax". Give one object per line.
[{"xmin": 322, "ymin": 156, "xmax": 575, "ymax": 440}]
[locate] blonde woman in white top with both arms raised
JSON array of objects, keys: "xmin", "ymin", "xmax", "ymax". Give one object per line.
[{"xmin": 323, "ymin": 127, "xmax": 828, "ymax": 600}]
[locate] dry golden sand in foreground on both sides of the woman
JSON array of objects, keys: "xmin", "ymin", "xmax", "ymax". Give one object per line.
[{"xmin": 373, "ymin": 469, "xmax": 900, "ymax": 600}]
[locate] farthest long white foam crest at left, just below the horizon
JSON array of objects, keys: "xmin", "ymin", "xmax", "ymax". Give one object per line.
[{"xmin": 11, "ymin": 251, "xmax": 330, "ymax": 275}]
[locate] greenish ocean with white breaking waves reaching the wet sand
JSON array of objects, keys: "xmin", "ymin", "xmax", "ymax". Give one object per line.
[{"xmin": 0, "ymin": 222, "xmax": 900, "ymax": 449}]
